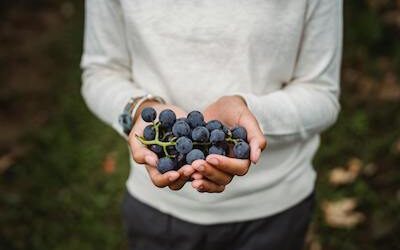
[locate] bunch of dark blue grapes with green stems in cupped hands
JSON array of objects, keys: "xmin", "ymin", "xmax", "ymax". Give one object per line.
[{"xmin": 136, "ymin": 107, "xmax": 250, "ymax": 173}]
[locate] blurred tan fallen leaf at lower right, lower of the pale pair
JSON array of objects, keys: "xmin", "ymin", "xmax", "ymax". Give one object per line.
[{"xmin": 322, "ymin": 198, "xmax": 365, "ymax": 228}]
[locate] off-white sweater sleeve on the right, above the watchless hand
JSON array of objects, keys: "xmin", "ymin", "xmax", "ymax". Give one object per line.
[{"xmin": 239, "ymin": 0, "xmax": 342, "ymax": 145}]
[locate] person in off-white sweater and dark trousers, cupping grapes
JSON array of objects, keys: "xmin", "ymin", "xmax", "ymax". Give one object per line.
[{"xmin": 81, "ymin": 0, "xmax": 342, "ymax": 250}]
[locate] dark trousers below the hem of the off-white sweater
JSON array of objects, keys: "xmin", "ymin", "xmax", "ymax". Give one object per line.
[{"xmin": 122, "ymin": 192, "xmax": 314, "ymax": 250}]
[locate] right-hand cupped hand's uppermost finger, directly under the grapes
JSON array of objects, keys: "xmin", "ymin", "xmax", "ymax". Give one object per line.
[{"xmin": 206, "ymin": 155, "xmax": 250, "ymax": 176}]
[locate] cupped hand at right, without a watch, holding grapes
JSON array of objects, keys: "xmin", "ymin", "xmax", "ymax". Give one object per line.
[{"xmin": 192, "ymin": 96, "xmax": 267, "ymax": 193}]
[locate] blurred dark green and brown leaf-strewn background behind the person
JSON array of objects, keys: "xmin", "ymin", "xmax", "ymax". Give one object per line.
[{"xmin": 0, "ymin": 0, "xmax": 400, "ymax": 250}]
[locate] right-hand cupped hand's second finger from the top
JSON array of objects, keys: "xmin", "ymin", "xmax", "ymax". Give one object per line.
[{"xmin": 192, "ymin": 160, "xmax": 233, "ymax": 185}]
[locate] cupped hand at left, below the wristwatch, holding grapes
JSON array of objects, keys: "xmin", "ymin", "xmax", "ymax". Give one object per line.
[{"xmin": 128, "ymin": 101, "xmax": 195, "ymax": 190}]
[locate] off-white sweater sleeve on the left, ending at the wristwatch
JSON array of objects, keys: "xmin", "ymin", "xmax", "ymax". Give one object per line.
[{"xmin": 81, "ymin": 0, "xmax": 146, "ymax": 135}]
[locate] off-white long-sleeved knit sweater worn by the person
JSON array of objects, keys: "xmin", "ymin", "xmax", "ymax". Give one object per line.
[{"xmin": 81, "ymin": 0, "xmax": 342, "ymax": 224}]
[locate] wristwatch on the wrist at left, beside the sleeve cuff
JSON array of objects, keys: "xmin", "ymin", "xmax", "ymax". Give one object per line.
[{"xmin": 118, "ymin": 94, "xmax": 165, "ymax": 135}]
